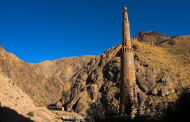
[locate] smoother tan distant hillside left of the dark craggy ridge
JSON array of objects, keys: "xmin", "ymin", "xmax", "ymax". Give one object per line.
[{"xmin": 0, "ymin": 47, "xmax": 93, "ymax": 106}]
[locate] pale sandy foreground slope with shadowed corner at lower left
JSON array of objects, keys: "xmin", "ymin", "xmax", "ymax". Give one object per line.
[{"xmin": 0, "ymin": 72, "xmax": 60, "ymax": 122}]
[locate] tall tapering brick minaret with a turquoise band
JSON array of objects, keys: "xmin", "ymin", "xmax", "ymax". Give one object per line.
[{"xmin": 119, "ymin": 7, "xmax": 137, "ymax": 119}]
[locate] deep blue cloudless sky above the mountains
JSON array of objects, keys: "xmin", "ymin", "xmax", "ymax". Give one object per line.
[{"xmin": 0, "ymin": 0, "xmax": 190, "ymax": 63}]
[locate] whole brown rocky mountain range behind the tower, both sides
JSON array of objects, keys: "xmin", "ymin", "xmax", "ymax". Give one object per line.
[{"xmin": 0, "ymin": 31, "xmax": 190, "ymax": 114}]
